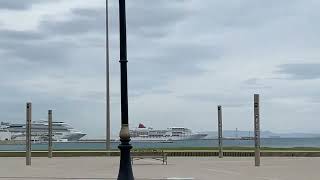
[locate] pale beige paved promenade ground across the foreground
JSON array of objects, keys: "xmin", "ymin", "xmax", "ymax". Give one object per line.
[{"xmin": 0, "ymin": 157, "xmax": 320, "ymax": 180}]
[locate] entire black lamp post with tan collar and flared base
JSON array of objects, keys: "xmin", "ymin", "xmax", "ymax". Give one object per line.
[{"xmin": 118, "ymin": 0, "xmax": 134, "ymax": 180}]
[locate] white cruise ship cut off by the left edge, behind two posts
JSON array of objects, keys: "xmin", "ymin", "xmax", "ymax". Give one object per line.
[{"xmin": 1, "ymin": 121, "xmax": 86, "ymax": 141}]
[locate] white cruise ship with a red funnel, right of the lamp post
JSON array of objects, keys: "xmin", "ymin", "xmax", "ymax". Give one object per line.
[{"xmin": 130, "ymin": 124, "xmax": 207, "ymax": 141}]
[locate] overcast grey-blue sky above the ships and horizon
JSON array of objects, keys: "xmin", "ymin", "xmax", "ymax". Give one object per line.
[{"xmin": 0, "ymin": 0, "xmax": 320, "ymax": 138}]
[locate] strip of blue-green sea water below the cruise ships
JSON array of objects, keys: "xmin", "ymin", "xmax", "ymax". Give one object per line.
[{"xmin": 0, "ymin": 138, "xmax": 320, "ymax": 151}]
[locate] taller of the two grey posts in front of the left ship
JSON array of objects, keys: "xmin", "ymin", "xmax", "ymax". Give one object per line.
[{"xmin": 26, "ymin": 102, "xmax": 32, "ymax": 166}]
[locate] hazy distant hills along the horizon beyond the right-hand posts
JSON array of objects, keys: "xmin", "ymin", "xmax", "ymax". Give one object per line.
[{"xmin": 204, "ymin": 130, "xmax": 320, "ymax": 139}]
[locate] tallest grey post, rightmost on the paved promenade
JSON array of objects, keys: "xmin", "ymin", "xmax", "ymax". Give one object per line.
[{"xmin": 254, "ymin": 94, "xmax": 260, "ymax": 166}]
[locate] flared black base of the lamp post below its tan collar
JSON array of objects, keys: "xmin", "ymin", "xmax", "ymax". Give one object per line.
[{"xmin": 118, "ymin": 139, "xmax": 134, "ymax": 180}]
